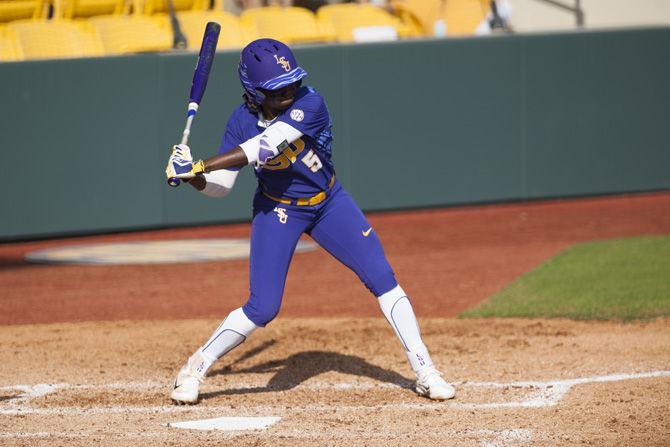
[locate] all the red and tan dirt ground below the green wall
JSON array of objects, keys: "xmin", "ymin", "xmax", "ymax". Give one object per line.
[{"xmin": 0, "ymin": 193, "xmax": 670, "ymax": 446}]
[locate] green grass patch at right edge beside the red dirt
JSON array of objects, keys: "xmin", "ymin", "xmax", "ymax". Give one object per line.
[{"xmin": 460, "ymin": 236, "xmax": 670, "ymax": 321}]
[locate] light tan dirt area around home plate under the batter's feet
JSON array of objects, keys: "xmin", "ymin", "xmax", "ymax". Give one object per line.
[{"xmin": 0, "ymin": 318, "xmax": 670, "ymax": 446}]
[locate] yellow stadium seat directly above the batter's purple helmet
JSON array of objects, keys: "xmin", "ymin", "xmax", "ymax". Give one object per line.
[{"xmin": 240, "ymin": 6, "xmax": 336, "ymax": 44}]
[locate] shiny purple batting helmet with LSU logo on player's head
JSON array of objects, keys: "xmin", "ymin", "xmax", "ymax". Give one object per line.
[{"xmin": 237, "ymin": 39, "xmax": 307, "ymax": 105}]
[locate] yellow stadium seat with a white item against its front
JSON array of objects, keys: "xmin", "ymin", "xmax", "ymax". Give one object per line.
[{"xmin": 316, "ymin": 3, "xmax": 415, "ymax": 42}]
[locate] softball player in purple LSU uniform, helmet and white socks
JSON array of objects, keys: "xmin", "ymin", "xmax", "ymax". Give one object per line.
[{"xmin": 166, "ymin": 39, "xmax": 455, "ymax": 403}]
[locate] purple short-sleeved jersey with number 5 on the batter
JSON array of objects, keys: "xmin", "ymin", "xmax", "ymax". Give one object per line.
[{"xmin": 219, "ymin": 86, "xmax": 335, "ymax": 199}]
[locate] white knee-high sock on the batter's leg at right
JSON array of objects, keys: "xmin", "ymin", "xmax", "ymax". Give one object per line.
[{"xmin": 378, "ymin": 286, "xmax": 433, "ymax": 372}]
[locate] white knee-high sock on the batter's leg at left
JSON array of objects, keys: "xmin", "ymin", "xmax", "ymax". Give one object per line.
[{"xmin": 194, "ymin": 307, "xmax": 258, "ymax": 376}]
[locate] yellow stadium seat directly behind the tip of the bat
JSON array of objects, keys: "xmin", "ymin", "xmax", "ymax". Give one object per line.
[{"xmin": 172, "ymin": 11, "xmax": 256, "ymax": 51}]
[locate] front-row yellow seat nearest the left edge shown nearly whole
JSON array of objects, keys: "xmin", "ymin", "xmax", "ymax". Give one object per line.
[{"xmin": 7, "ymin": 20, "xmax": 102, "ymax": 59}]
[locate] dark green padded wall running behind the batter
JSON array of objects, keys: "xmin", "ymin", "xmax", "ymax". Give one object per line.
[{"xmin": 0, "ymin": 28, "xmax": 670, "ymax": 240}]
